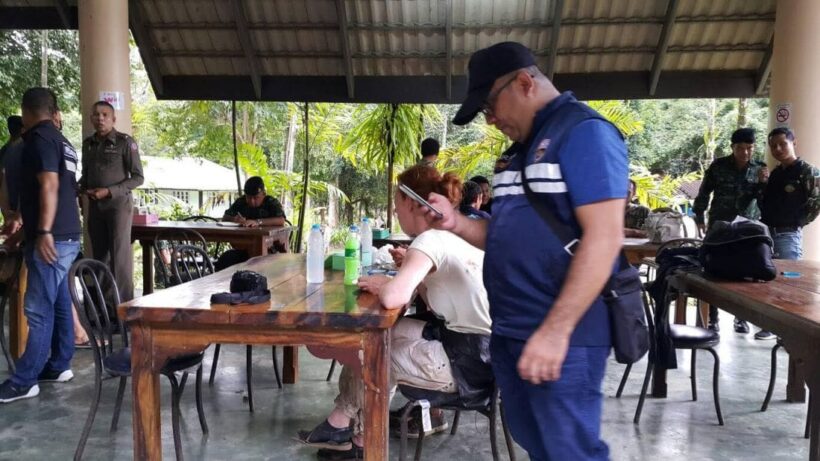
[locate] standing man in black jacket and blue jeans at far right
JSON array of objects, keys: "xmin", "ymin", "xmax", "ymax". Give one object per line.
[{"xmin": 760, "ymin": 128, "xmax": 820, "ymax": 259}]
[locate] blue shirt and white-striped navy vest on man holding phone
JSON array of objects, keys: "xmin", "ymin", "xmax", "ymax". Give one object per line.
[{"xmin": 484, "ymin": 92, "xmax": 628, "ymax": 346}]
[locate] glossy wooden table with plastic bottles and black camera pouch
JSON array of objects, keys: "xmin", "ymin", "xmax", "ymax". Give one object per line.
[{"xmin": 119, "ymin": 254, "xmax": 403, "ymax": 461}]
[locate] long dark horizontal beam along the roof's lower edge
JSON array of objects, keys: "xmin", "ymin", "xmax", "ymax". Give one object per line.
[{"xmin": 162, "ymin": 71, "xmax": 755, "ymax": 104}]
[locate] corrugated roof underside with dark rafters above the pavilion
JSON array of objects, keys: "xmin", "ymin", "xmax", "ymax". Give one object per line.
[{"xmin": 0, "ymin": 0, "xmax": 776, "ymax": 103}]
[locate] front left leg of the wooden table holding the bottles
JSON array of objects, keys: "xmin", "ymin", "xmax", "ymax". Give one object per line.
[{"xmin": 131, "ymin": 324, "xmax": 162, "ymax": 460}]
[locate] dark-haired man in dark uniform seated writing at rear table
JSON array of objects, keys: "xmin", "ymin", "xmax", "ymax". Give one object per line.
[{"xmin": 214, "ymin": 176, "xmax": 287, "ymax": 271}]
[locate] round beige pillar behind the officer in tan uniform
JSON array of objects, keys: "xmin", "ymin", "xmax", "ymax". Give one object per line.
[{"xmin": 77, "ymin": 0, "xmax": 131, "ymax": 138}]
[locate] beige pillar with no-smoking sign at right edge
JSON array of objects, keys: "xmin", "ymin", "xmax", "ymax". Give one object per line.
[{"xmin": 769, "ymin": 0, "xmax": 820, "ymax": 260}]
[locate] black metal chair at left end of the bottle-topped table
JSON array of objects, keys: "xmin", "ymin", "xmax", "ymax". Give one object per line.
[{"xmin": 68, "ymin": 259, "xmax": 208, "ymax": 460}]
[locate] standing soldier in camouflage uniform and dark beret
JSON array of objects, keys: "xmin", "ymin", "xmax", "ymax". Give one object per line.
[{"xmin": 692, "ymin": 128, "xmax": 769, "ymax": 333}]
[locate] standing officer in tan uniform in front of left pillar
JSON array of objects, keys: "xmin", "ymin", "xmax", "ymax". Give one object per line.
[{"xmin": 80, "ymin": 101, "xmax": 144, "ymax": 301}]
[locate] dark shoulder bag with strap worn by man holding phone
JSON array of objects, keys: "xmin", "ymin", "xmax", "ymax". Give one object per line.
[{"xmin": 521, "ymin": 165, "xmax": 649, "ymax": 364}]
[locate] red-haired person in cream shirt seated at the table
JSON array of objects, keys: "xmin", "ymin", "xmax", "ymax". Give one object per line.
[{"xmin": 298, "ymin": 165, "xmax": 493, "ymax": 459}]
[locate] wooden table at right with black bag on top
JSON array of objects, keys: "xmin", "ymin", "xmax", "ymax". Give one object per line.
[{"xmin": 668, "ymin": 260, "xmax": 820, "ymax": 461}]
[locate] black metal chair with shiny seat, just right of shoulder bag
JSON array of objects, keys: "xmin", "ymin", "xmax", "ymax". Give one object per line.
[{"xmin": 615, "ymin": 280, "xmax": 723, "ymax": 426}]
